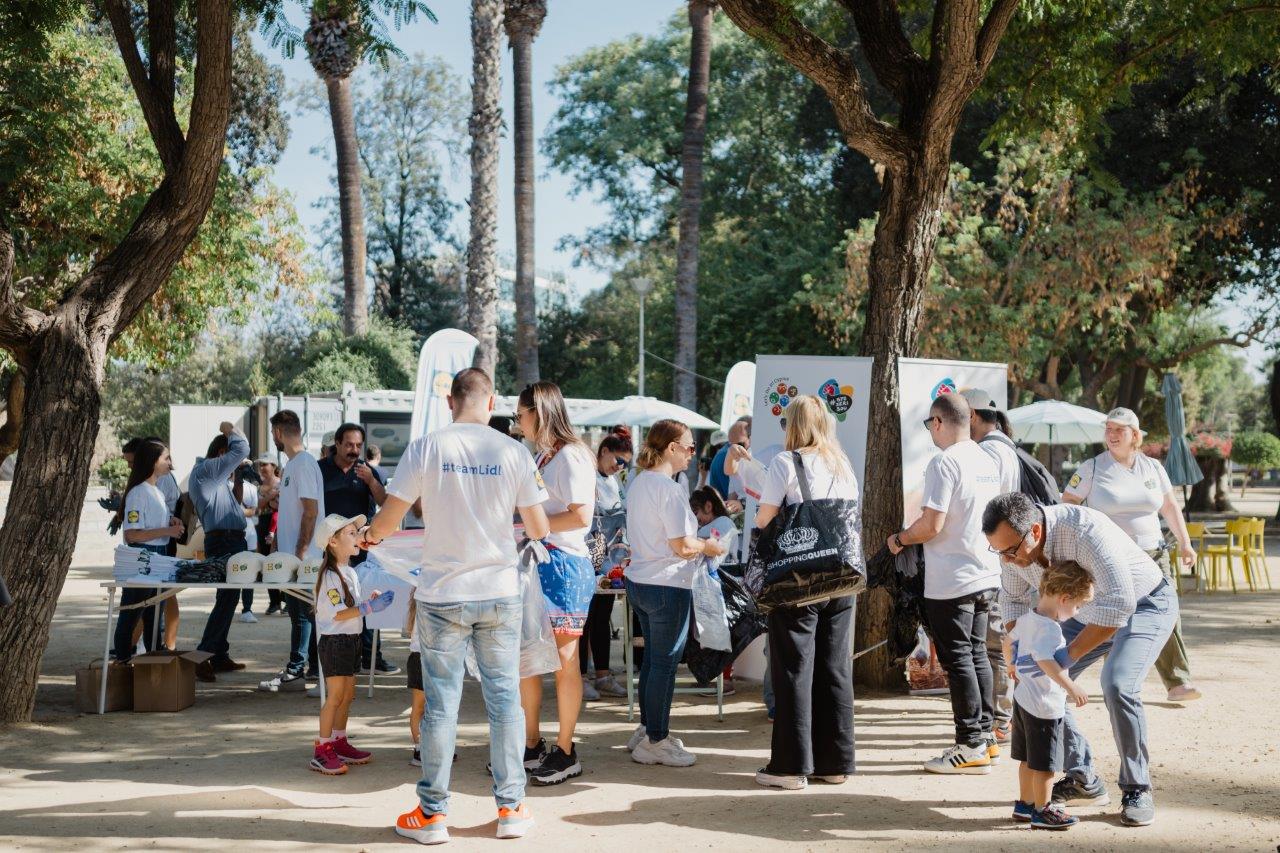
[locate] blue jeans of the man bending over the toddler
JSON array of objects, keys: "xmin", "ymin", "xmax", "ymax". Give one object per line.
[{"xmin": 1062, "ymin": 581, "xmax": 1178, "ymax": 792}]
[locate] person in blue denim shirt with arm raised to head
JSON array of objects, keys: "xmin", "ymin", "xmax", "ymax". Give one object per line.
[{"xmin": 187, "ymin": 421, "xmax": 248, "ymax": 681}]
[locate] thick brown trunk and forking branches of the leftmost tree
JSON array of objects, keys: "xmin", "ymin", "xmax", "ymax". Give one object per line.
[{"xmin": 0, "ymin": 0, "xmax": 236, "ymax": 722}]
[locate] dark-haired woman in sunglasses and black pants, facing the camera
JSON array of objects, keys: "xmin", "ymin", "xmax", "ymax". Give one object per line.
[{"xmin": 577, "ymin": 427, "xmax": 631, "ymax": 701}]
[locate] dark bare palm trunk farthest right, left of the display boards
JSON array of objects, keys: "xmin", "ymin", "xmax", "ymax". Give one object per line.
[{"xmin": 675, "ymin": 0, "xmax": 716, "ymax": 411}]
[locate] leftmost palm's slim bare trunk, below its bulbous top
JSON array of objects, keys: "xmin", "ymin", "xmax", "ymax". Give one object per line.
[{"xmin": 325, "ymin": 77, "xmax": 369, "ymax": 334}]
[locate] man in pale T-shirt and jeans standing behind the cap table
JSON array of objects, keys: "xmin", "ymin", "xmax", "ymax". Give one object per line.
[{"xmin": 259, "ymin": 409, "xmax": 325, "ymax": 693}]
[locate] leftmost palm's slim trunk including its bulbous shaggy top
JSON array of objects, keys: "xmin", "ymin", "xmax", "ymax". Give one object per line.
[{"xmin": 305, "ymin": 0, "xmax": 369, "ymax": 334}]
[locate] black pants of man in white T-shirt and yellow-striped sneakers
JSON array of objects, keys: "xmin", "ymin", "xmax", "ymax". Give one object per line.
[{"xmin": 924, "ymin": 589, "xmax": 996, "ymax": 747}]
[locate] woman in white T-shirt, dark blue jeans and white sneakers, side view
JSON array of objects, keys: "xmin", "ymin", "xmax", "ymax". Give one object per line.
[{"xmin": 625, "ymin": 420, "xmax": 724, "ymax": 767}]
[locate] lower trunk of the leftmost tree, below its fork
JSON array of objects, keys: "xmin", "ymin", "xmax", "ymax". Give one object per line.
[{"xmin": 0, "ymin": 324, "xmax": 105, "ymax": 721}]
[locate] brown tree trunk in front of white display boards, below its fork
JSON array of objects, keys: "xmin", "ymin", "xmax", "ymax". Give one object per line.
[{"xmin": 855, "ymin": 159, "xmax": 947, "ymax": 688}]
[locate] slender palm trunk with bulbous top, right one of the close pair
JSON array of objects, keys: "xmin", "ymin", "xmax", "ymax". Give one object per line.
[{"xmin": 506, "ymin": 0, "xmax": 547, "ymax": 386}]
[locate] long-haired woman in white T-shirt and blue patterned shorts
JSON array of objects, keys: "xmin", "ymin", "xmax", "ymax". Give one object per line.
[{"xmin": 516, "ymin": 382, "xmax": 595, "ymax": 785}]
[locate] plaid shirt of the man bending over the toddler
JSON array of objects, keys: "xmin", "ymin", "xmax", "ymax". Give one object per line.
[{"xmin": 1000, "ymin": 503, "xmax": 1164, "ymax": 628}]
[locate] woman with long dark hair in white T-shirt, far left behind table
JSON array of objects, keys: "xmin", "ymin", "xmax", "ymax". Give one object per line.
[{"xmin": 115, "ymin": 441, "xmax": 182, "ymax": 663}]
